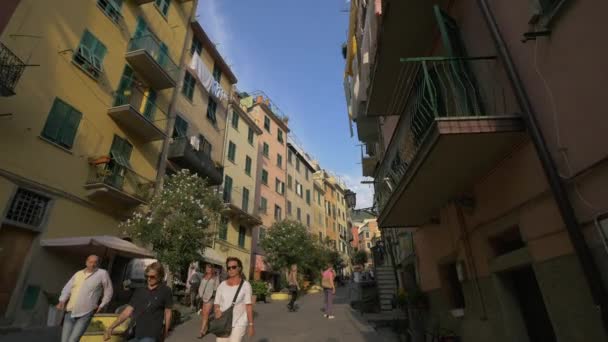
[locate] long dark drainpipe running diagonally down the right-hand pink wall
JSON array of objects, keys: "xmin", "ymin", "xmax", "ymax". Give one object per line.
[{"xmin": 477, "ymin": 0, "xmax": 608, "ymax": 333}]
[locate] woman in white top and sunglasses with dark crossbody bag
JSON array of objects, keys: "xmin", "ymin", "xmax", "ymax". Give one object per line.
[{"xmin": 214, "ymin": 257, "xmax": 255, "ymax": 342}]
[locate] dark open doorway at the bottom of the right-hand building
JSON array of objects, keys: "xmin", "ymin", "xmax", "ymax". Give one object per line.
[{"xmin": 504, "ymin": 265, "xmax": 557, "ymax": 342}]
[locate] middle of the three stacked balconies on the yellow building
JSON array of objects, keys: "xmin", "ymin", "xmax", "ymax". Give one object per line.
[{"xmin": 108, "ymin": 87, "xmax": 167, "ymax": 142}]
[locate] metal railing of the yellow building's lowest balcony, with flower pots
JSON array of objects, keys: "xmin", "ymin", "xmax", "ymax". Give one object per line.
[{"xmin": 87, "ymin": 157, "xmax": 154, "ymax": 202}]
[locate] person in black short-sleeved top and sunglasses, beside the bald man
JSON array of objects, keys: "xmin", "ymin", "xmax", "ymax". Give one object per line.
[{"xmin": 104, "ymin": 262, "xmax": 173, "ymax": 342}]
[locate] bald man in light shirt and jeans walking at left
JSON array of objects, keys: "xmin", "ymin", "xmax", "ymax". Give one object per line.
[{"xmin": 57, "ymin": 255, "xmax": 113, "ymax": 342}]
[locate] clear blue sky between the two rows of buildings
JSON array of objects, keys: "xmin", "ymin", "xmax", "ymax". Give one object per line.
[{"xmin": 197, "ymin": 0, "xmax": 372, "ymax": 207}]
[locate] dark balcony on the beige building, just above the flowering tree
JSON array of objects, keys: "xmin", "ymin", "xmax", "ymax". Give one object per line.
[{"xmin": 168, "ymin": 138, "xmax": 223, "ymax": 185}]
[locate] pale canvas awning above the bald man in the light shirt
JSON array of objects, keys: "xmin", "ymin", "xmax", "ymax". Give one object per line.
[{"xmin": 40, "ymin": 235, "xmax": 154, "ymax": 258}]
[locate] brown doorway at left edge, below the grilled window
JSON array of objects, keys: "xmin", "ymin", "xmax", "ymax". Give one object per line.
[{"xmin": 0, "ymin": 225, "xmax": 36, "ymax": 316}]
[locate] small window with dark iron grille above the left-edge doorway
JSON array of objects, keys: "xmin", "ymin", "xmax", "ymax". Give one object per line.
[{"xmin": 6, "ymin": 188, "xmax": 50, "ymax": 227}]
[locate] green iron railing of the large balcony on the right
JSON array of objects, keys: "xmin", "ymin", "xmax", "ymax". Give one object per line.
[{"xmin": 375, "ymin": 57, "xmax": 518, "ymax": 212}]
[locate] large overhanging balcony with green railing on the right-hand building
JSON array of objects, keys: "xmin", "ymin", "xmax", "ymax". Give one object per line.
[{"xmin": 375, "ymin": 57, "xmax": 525, "ymax": 227}]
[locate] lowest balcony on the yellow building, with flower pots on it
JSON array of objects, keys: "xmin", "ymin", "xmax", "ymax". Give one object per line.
[{"xmin": 84, "ymin": 157, "xmax": 154, "ymax": 206}]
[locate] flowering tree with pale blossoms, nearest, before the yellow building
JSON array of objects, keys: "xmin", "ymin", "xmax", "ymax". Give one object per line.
[{"xmin": 121, "ymin": 169, "xmax": 223, "ymax": 272}]
